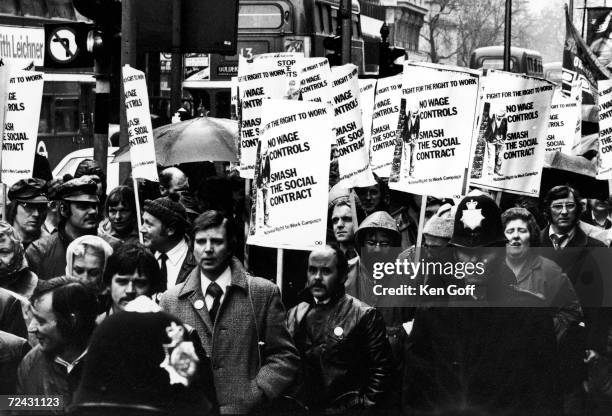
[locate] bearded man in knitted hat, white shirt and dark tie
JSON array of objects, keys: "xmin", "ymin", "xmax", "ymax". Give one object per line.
[{"xmin": 140, "ymin": 194, "xmax": 196, "ymax": 292}]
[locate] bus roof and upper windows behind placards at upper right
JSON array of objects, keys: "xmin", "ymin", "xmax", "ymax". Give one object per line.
[{"xmin": 470, "ymin": 46, "xmax": 544, "ymax": 77}]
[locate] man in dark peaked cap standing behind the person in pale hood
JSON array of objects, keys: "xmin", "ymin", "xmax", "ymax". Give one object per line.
[{"xmin": 26, "ymin": 176, "xmax": 118, "ymax": 280}]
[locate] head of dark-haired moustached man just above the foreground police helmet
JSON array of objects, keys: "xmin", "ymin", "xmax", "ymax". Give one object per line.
[{"xmin": 98, "ymin": 243, "xmax": 161, "ymax": 323}]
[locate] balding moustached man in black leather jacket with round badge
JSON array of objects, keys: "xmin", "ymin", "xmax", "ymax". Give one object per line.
[{"xmin": 287, "ymin": 245, "xmax": 392, "ymax": 415}]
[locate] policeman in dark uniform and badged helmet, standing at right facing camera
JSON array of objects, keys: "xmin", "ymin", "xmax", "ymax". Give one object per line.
[{"xmin": 404, "ymin": 193, "xmax": 561, "ymax": 415}]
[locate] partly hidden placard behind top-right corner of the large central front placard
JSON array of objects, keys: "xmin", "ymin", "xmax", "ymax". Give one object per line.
[{"xmin": 298, "ymin": 58, "xmax": 331, "ymax": 103}]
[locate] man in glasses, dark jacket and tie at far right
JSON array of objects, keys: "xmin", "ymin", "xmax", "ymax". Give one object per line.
[{"xmin": 540, "ymin": 185, "xmax": 610, "ymax": 412}]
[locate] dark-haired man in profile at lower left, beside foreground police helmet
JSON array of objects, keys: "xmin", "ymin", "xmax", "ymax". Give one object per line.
[{"xmin": 17, "ymin": 277, "xmax": 97, "ymax": 406}]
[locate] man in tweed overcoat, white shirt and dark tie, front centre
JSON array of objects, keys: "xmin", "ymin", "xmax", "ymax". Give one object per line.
[{"xmin": 160, "ymin": 210, "xmax": 299, "ymax": 414}]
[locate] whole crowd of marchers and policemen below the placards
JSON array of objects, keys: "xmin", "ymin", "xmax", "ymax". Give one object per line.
[{"xmin": 0, "ymin": 160, "xmax": 612, "ymax": 415}]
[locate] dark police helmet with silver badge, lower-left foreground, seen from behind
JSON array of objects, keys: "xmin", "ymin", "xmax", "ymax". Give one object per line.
[{"xmin": 70, "ymin": 312, "xmax": 215, "ymax": 415}]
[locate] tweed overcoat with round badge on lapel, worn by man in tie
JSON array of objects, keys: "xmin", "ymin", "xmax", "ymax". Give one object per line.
[{"xmin": 160, "ymin": 258, "xmax": 299, "ymax": 414}]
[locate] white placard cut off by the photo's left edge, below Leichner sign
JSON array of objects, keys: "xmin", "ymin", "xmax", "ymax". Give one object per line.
[{"xmin": 2, "ymin": 66, "xmax": 44, "ymax": 186}]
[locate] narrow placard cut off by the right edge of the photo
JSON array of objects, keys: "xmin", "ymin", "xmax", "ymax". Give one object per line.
[{"xmin": 597, "ymin": 80, "xmax": 612, "ymax": 179}]
